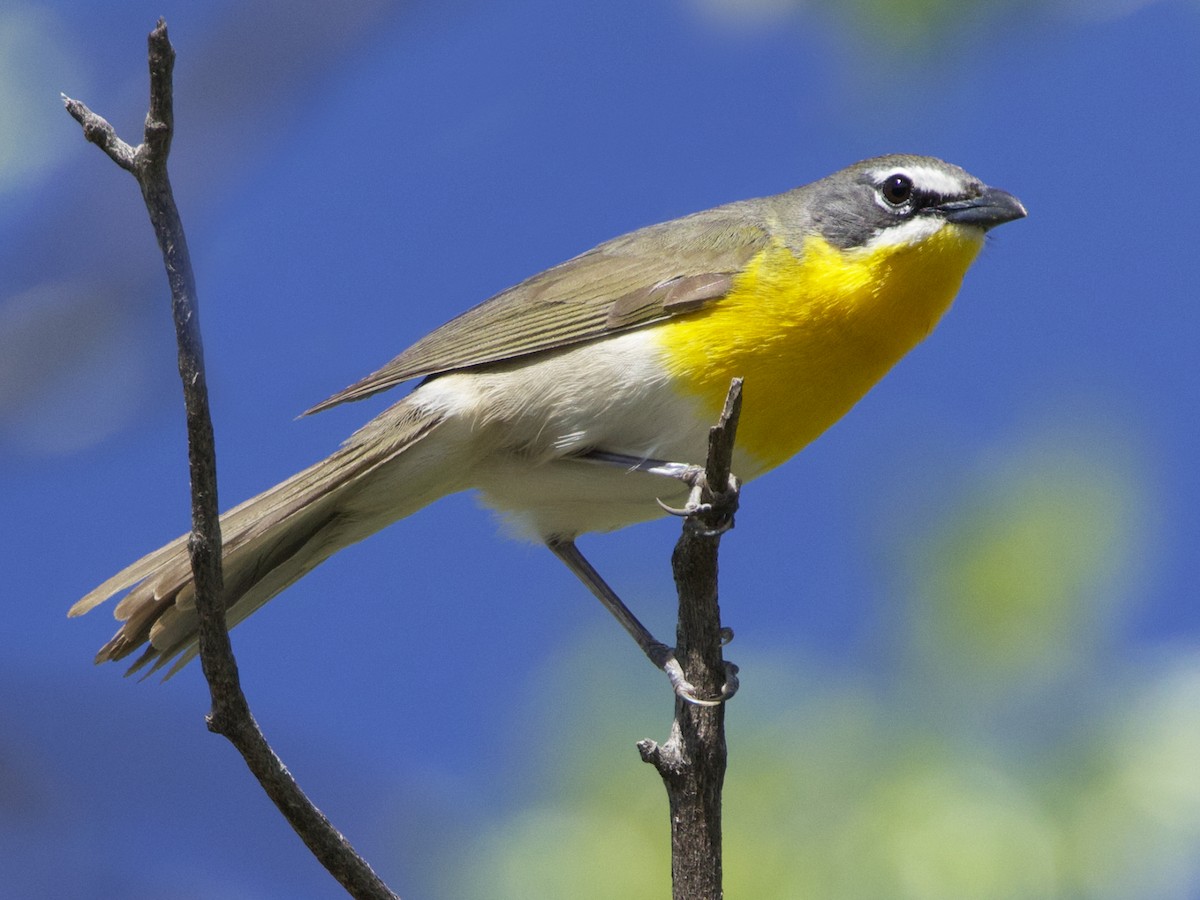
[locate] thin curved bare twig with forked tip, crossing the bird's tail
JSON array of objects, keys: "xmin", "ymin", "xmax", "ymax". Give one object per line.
[{"xmin": 62, "ymin": 19, "xmax": 397, "ymax": 900}]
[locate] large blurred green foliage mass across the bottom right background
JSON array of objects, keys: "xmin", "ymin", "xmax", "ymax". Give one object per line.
[{"xmin": 446, "ymin": 440, "xmax": 1200, "ymax": 900}]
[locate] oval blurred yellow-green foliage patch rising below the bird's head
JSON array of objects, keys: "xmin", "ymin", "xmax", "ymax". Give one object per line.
[{"xmin": 901, "ymin": 442, "xmax": 1146, "ymax": 689}]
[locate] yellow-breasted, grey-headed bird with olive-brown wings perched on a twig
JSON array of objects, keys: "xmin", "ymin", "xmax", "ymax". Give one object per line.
[{"xmin": 68, "ymin": 154, "xmax": 1027, "ymax": 702}]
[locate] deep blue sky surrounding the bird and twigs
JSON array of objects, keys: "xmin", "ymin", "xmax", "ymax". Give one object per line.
[{"xmin": 0, "ymin": 0, "xmax": 1200, "ymax": 898}]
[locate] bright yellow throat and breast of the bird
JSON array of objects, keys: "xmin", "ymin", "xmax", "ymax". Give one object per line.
[{"xmin": 658, "ymin": 224, "xmax": 983, "ymax": 475}]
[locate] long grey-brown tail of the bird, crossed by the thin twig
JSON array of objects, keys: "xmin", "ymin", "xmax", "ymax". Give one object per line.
[{"xmin": 68, "ymin": 401, "xmax": 463, "ymax": 678}]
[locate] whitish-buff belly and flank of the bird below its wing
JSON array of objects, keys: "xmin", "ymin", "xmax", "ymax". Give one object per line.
[{"xmin": 412, "ymin": 329, "xmax": 758, "ymax": 540}]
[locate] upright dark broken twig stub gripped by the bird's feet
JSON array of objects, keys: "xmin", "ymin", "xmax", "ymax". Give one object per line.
[{"xmin": 637, "ymin": 378, "xmax": 742, "ymax": 900}]
